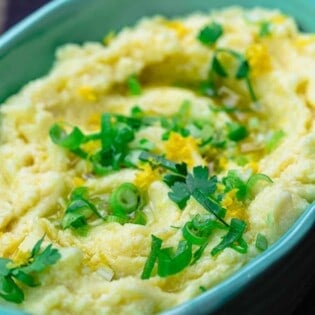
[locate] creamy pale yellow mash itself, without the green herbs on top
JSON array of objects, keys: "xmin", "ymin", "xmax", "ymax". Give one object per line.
[{"xmin": 0, "ymin": 8, "xmax": 315, "ymax": 315}]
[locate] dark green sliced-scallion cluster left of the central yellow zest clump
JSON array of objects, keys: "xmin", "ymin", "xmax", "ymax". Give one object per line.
[{"xmin": 49, "ymin": 110, "xmax": 151, "ymax": 175}]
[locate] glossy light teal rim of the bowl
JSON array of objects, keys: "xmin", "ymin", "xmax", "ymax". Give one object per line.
[{"xmin": 0, "ymin": 0, "xmax": 315, "ymax": 315}]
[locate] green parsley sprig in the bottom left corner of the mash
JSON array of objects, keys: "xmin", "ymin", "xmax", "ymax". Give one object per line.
[{"xmin": 0, "ymin": 236, "xmax": 61, "ymax": 304}]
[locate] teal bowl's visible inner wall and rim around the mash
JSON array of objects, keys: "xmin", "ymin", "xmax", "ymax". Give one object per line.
[{"xmin": 0, "ymin": 0, "xmax": 315, "ymax": 315}]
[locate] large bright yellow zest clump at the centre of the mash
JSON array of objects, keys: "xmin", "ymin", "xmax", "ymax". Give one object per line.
[{"xmin": 164, "ymin": 132, "xmax": 197, "ymax": 166}]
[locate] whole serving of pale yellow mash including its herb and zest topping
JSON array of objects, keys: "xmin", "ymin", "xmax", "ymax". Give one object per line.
[{"xmin": 0, "ymin": 8, "xmax": 315, "ymax": 315}]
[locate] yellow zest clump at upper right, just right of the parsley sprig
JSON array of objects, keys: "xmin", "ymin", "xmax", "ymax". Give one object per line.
[{"xmin": 246, "ymin": 43, "xmax": 271, "ymax": 75}]
